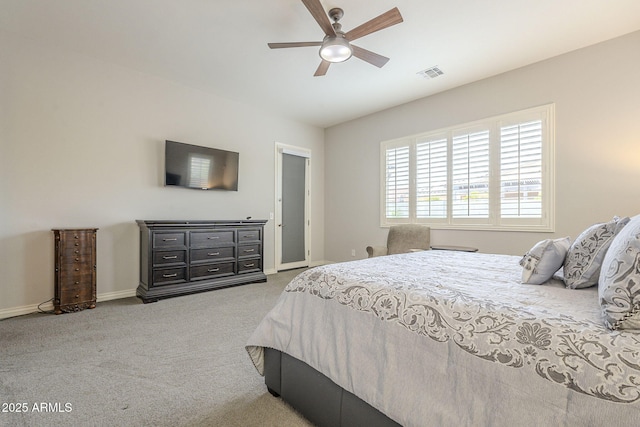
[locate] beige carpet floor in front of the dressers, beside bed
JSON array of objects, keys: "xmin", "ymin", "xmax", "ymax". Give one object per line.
[{"xmin": 0, "ymin": 270, "xmax": 310, "ymax": 427}]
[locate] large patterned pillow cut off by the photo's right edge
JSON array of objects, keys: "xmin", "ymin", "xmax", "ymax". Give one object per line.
[{"xmin": 598, "ymin": 215, "xmax": 640, "ymax": 329}]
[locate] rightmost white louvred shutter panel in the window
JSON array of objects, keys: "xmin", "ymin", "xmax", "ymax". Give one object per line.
[{"xmin": 500, "ymin": 120, "xmax": 543, "ymax": 218}]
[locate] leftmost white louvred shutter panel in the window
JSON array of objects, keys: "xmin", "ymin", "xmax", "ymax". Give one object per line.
[{"xmin": 385, "ymin": 146, "xmax": 409, "ymax": 218}]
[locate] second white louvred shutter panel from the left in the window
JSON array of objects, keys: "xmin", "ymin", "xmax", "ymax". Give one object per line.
[{"xmin": 416, "ymin": 138, "xmax": 447, "ymax": 218}]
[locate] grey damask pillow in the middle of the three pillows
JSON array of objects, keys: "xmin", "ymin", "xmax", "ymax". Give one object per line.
[{"xmin": 564, "ymin": 217, "xmax": 629, "ymax": 289}]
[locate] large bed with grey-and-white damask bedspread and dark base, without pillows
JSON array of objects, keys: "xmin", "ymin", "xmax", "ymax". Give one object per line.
[{"xmin": 246, "ymin": 251, "xmax": 640, "ymax": 426}]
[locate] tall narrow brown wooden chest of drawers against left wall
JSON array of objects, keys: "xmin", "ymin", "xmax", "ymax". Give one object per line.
[{"xmin": 52, "ymin": 228, "xmax": 98, "ymax": 314}]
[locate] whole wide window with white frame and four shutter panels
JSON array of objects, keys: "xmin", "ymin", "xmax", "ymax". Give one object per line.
[{"xmin": 381, "ymin": 104, "xmax": 555, "ymax": 231}]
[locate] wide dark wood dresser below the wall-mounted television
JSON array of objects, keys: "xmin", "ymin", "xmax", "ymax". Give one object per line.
[{"xmin": 136, "ymin": 220, "xmax": 267, "ymax": 303}]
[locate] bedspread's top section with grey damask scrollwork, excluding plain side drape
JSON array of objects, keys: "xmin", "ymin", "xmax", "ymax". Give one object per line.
[{"xmin": 285, "ymin": 251, "xmax": 640, "ymax": 403}]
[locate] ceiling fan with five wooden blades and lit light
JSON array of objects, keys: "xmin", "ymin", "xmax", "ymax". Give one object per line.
[{"xmin": 268, "ymin": 0, "xmax": 402, "ymax": 76}]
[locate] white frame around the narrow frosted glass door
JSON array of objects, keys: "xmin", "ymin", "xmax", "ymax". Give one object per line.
[{"xmin": 274, "ymin": 142, "xmax": 311, "ymax": 271}]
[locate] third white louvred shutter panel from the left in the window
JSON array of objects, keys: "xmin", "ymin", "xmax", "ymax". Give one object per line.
[{"xmin": 451, "ymin": 130, "xmax": 489, "ymax": 218}]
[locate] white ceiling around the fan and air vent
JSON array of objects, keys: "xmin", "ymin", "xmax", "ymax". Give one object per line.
[{"xmin": 0, "ymin": 0, "xmax": 640, "ymax": 127}]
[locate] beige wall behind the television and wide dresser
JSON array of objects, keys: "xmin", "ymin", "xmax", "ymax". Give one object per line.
[{"xmin": 0, "ymin": 34, "xmax": 324, "ymax": 318}]
